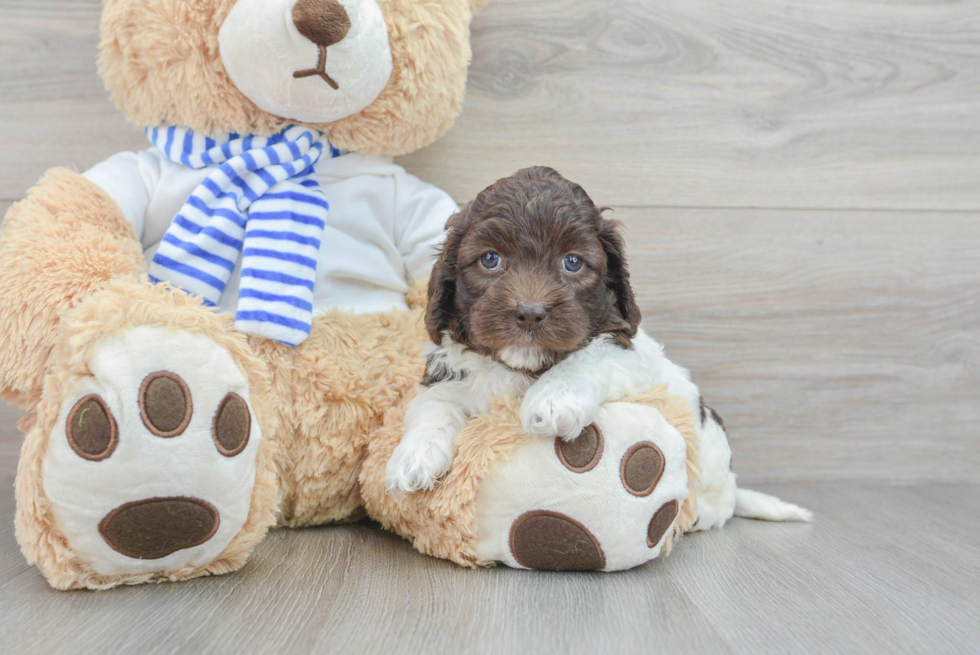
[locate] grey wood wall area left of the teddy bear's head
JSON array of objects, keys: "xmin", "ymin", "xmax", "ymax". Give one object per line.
[{"xmin": 0, "ymin": 0, "xmax": 146, "ymax": 200}]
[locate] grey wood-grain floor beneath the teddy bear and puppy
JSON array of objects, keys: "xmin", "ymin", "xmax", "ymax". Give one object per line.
[{"xmin": 0, "ymin": 446, "xmax": 980, "ymax": 655}]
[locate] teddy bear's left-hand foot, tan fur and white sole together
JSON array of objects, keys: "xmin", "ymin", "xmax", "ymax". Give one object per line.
[{"xmin": 16, "ymin": 279, "xmax": 277, "ymax": 589}]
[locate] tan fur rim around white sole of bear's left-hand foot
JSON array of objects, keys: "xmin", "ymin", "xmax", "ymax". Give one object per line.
[{"xmin": 16, "ymin": 275, "xmax": 279, "ymax": 589}]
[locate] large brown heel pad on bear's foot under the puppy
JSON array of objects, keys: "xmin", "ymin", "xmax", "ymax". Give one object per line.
[{"xmin": 510, "ymin": 510, "xmax": 606, "ymax": 571}]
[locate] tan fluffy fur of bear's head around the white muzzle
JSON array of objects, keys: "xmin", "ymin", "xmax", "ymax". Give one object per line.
[{"xmin": 99, "ymin": 0, "xmax": 482, "ymax": 155}]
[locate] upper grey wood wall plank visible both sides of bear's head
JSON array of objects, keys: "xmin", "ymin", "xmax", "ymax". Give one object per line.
[{"xmin": 0, "ymin": 0, "xmax": 980, "ymax": 210}]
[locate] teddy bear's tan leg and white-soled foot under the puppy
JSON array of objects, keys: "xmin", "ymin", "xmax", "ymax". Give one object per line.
[{"xmin": 361, "ymin": 387, "xmax": 698, "ymax": 571}]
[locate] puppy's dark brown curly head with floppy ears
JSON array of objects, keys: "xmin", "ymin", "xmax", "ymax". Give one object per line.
[{"xmin": 426, "ymin": 168, "xmax": 640, "ymax": 372}]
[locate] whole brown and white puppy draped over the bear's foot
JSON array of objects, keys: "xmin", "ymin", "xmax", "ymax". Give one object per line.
[{"xmin": 386, "ymin": 167, "xmax": 808, "ymax": 529}]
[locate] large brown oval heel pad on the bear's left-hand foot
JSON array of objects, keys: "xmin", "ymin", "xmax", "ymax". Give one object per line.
[{"xmin": 99, "ymin": 498, "xmax": 221, "ymax": 559}]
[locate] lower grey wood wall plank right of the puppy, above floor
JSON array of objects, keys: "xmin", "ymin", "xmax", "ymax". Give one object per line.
[{"xmin": 620, "ymin": 208, "xmax": 980, "ymax": 484}]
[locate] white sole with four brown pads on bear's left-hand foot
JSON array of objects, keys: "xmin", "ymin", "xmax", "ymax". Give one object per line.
[{"xmin": 43, "ymin": 327, "xmax": 260, "ymax": 575}]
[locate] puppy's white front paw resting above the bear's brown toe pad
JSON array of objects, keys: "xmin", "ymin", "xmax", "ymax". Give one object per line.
[{"xmin": 521, "ymin": 382, "xmax": 599, "ymax": 441}]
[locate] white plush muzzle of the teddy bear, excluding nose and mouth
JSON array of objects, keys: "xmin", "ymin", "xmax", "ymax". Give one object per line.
[{"xmin": 218, "ymin": 0, "xmax": 392, "ymax": 123}]
